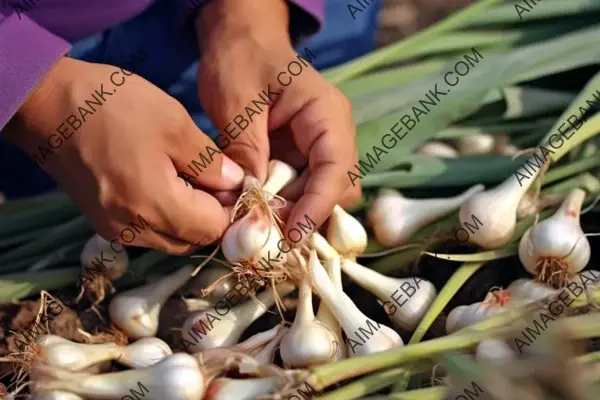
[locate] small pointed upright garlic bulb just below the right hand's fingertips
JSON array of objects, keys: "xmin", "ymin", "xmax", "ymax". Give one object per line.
[{"xmin": 327, "ymin": 205, "xmax": 367, "ymax": 257}]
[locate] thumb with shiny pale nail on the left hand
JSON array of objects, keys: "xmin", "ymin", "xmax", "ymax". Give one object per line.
[{"xmin": 165, "ymin": 118, "xmax": 244, "ymax": 190}]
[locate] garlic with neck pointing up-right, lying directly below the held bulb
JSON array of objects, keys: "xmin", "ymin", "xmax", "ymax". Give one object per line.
[{"xmin": 181, "ymin": 283, "xmax": 294, "ymax": 353}]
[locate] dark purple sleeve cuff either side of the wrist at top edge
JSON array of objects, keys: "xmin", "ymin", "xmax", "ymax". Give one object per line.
[{"xmin": 178, "ymin": 0, "xmax": 325, "ymax": 42}]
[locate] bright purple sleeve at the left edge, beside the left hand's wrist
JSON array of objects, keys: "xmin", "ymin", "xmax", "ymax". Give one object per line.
[{"xmin": 0, "ymin": 10, "xmax": 70, "ymax": 130}]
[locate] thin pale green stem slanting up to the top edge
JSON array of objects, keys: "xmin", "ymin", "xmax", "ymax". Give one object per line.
[{"xmin": 323, "ymin": 0, "xmax": 502, "ymax": 84}]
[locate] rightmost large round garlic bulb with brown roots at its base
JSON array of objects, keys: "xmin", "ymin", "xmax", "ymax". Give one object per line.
[{"xmin": 519, "ymin": 189, "xmax": 591, "ymax": 287}]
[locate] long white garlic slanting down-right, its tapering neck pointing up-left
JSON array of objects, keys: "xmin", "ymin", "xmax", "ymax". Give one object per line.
[{"xmin": 309, "ymin": 250, "xmax": 404, "ymax": 355}]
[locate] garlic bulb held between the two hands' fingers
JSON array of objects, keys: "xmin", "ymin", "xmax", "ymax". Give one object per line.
[{"xmin": 221, "ymin": 207, "xmax": 286, "ymax": 264}]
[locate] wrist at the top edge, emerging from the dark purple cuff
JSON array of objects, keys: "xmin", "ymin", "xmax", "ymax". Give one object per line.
[{"xmin": 196, "ymin": 0, "xmax": 291, "ymax": 53}]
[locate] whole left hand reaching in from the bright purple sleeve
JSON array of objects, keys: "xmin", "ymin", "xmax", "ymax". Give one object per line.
[{"xmin": 6, "ymin": 57, "xmax": 243, "ymax": 254}]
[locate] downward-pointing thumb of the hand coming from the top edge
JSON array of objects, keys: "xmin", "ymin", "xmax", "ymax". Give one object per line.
[{"xmin": 207, "ymin": 95, "xmax": 270, "ymax": 182}]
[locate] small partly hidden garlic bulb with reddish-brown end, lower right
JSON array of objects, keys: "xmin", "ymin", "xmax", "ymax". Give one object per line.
[{"xmin": 446, "ymin": 290, "xmax": 510, "ymax": 334}]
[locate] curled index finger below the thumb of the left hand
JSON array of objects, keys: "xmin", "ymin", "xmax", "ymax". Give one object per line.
[{"xmin": 154, "ymin": 164, "xmax": 229, "ymax": 246}]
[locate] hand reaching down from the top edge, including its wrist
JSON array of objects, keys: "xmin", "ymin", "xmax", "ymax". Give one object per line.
[{"xmin": 197, "ymin": 0, "xmax": 360, "ymax": 238}]
